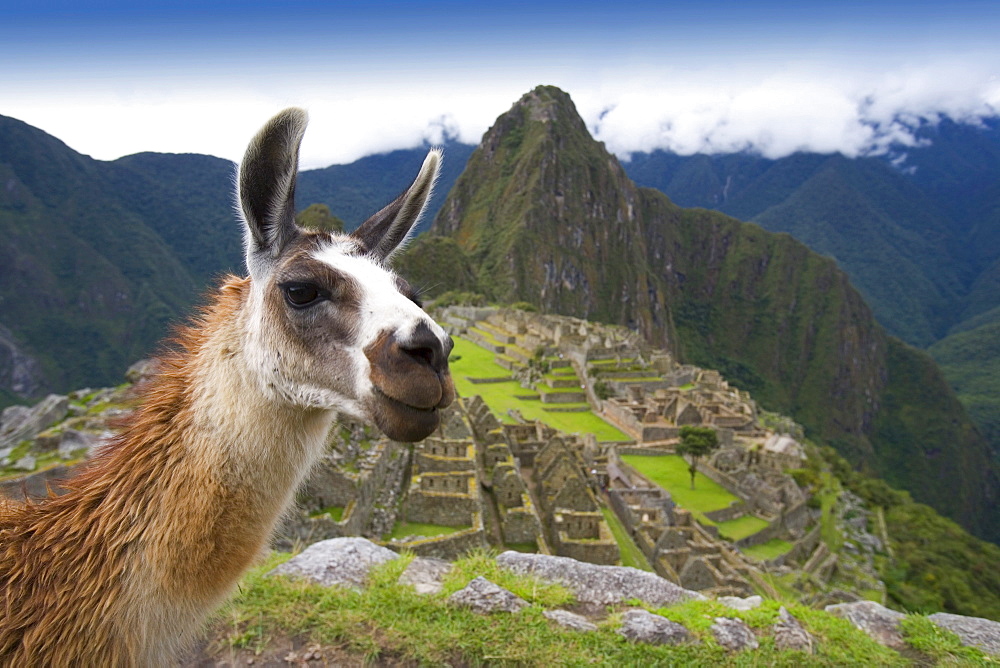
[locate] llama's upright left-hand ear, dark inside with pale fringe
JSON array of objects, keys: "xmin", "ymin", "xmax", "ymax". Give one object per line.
[{"xmin": 237, "ymin": 107, "xmax": 309, "ymax": 267}]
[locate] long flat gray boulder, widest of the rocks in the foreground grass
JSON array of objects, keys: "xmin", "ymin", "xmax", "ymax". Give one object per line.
[{"xmin": 497, "ymin": 551, "xmax": 704, "ymax": 606}]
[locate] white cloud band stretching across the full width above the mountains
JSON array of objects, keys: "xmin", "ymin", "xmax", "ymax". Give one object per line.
[{"xmin": 0, "ymin": 54, "xmax": 1000, "ymax": 168}]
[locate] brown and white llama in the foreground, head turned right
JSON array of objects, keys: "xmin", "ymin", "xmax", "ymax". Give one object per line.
[{"xmin": 0, "ymin": 109, "xmax": 455, "ymax": 666}]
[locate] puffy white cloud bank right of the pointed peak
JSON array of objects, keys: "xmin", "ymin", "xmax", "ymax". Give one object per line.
[{"xmin": 578, "ymin": 65, "xmax": 1000, "ymax": 159}]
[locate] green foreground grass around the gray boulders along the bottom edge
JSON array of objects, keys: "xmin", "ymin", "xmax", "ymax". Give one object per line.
[{"xmin": 221, "ymin": 552, "xmax": 916, "ymax": 667}]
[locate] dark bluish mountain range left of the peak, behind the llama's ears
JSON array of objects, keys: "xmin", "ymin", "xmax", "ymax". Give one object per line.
[{"xmin": 0, "ymin": 116, "xmax": 472, "ymax": 396}]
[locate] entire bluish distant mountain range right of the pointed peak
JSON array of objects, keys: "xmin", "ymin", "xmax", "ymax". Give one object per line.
[{"xmin": 624, "ymin": 120, "xmax": 1000, "ymax": 347}]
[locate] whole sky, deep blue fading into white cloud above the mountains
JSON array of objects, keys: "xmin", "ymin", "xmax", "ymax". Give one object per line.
[{"xmin": 0, "ymin": 0, "xmax": 1000, "ymax": 167}]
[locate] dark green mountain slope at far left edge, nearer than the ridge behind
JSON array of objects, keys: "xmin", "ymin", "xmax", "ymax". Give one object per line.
[{"xmin": 0, "ymin": 112, "xmax": 196, "ymax": 389}]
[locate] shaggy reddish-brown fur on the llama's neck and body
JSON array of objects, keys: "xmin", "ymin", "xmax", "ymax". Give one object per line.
[{"xmin": 0, "ymin": 278, "xmax": 329, "ymax": 666}]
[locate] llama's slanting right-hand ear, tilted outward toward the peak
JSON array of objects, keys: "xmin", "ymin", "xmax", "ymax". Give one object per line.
[{"xmin": 351, "ymin": 149, "xmax": 442, "ymax": 260}]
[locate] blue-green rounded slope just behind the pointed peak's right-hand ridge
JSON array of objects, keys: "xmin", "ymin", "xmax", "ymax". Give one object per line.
[{"xmin": 625, "ymin": 152, "xmax": 977, "ymax": 346}]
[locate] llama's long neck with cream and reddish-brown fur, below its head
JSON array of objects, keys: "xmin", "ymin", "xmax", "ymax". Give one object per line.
[{"xmin": 118, "ymin": 280, "xmax": 334, "ymax": 656}]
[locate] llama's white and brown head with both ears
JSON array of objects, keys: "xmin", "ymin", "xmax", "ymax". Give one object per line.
[{"xmin": 237, "ymin": 109, "xmax": 455, "ymax": 441}]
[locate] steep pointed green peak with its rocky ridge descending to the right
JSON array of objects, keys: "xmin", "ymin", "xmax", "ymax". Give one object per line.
[{"xmin": 404, "ymin": 87, "xmax": 1000, "ymax": 538}]
